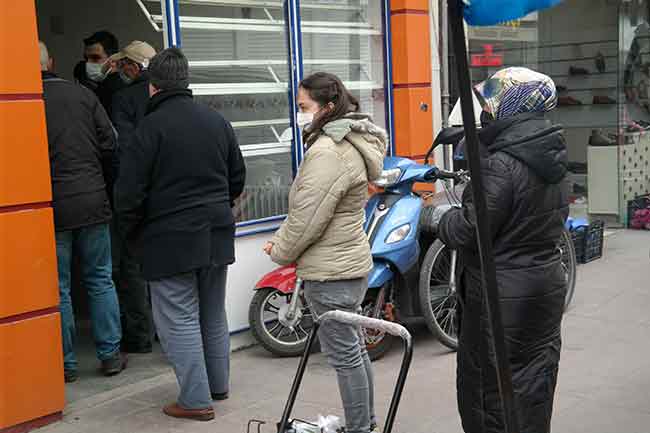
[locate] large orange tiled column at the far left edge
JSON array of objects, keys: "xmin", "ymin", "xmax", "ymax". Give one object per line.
[{"xmin": 0, "ymin": 0, "xmax": 64, "ymax": 433}]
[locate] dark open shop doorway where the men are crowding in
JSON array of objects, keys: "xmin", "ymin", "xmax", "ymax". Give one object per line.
[{"xmin": 36, "ymin": 0, "xmax": 168, "ymax": 404}]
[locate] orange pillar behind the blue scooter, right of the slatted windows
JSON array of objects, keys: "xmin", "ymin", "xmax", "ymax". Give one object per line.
[{"xmin": 390, "ymin": 0, "xmax": 433, "ymax": 160}]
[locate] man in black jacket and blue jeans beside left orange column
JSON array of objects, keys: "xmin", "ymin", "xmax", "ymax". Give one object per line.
[{"xmin": 40, "ymin": 42, "xmax": 125, "ymax": 382}]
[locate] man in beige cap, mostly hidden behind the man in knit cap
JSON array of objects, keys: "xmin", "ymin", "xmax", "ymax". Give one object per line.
[{"xmin": 108, "ymin": 41, "xmax": 156, "ymax": 353}]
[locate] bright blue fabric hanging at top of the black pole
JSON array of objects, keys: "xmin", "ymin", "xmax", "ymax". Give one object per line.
[{"xmin": 465, "ymin": 0, "xmax": 562, "ymax": 26}]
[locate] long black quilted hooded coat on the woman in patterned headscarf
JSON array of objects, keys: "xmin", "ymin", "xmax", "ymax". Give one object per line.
[{"xmin": 439, "ymin": 114, "xmax": 568, "ymax": 433}]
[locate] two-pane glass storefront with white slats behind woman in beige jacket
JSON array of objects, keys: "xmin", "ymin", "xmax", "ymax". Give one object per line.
[{"xmin": 170, "ymin": 0, "xmax": 387, "ymax": 222}]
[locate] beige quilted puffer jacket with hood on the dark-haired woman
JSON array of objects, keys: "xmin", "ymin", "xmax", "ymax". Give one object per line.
[{"xmin": 271, "ymin": 113, "xmax": 388, "ymax": 281}]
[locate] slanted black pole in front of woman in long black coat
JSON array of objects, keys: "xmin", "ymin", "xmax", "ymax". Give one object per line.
[{"xmin": 449, "ymin": 0, "xmax": 519, "ymax": 433}]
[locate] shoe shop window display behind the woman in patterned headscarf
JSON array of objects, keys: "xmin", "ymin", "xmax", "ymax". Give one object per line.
[{"xmin": 451, "ymin": 0, "xmax": 650, "ymax": 222}]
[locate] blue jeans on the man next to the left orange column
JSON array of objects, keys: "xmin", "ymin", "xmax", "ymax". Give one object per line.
[{"xmin": 56, "ymin": 224, "xmax": 122, "ymax": 370}]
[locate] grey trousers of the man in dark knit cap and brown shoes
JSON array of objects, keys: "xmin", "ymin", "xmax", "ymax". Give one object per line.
[{"xmin": 150, "ymin": 266, "xmax": 230, "ymax": 409}]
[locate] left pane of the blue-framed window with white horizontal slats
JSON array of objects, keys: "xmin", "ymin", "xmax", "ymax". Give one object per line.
[{"xmin": 171, "ymin": 0, "xmax": 293, "ymax": 222}]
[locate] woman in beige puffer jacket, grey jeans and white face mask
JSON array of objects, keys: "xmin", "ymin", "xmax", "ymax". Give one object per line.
[{"xmin": 265, "ymin": 73, "xmax": 387, "ymax": 433}]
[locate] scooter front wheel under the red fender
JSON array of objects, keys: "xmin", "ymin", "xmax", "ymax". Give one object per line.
[{"xmin": 248, "ymin": 288, "xmax": 313, "ymax": 357}]
